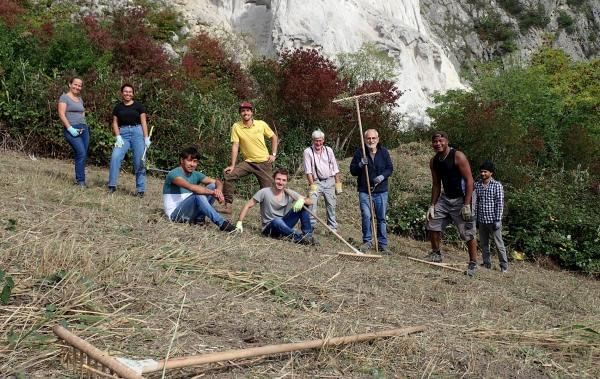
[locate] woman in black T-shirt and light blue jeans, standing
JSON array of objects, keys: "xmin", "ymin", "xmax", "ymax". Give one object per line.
[{"xmin": 108, "ymin": 84, "xmax": 150, "ymax": 197}]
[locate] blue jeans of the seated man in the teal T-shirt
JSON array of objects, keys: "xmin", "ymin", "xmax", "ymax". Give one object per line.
[{"xmin": 171, "ymin": 184, "xmax": 225, "ymax": 226}]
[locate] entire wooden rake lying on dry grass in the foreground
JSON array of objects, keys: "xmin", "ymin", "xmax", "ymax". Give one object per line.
[{"xmin": 52, "ymin": 325, "xmax": 426, "ymax": 379}]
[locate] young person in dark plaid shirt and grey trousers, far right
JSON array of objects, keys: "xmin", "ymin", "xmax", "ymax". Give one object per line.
[{"xmin": 475, "ymin": 161, "xmax": 508, "ymax": 273}]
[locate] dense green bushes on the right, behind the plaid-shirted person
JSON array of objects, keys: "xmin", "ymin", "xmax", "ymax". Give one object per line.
[{"xmin": 429, "ymin": 50, "xmax": 600, "ymax": 273}]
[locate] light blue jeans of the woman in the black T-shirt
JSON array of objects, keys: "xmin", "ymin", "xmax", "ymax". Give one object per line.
[{"xmin": 108, "ymin": 125, "xmax": 146, "ymax": 192}]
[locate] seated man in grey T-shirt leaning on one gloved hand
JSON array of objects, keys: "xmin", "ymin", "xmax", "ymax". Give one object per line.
[{"xmin": 236, "ymin": 169, "xmax": 316, "ymax": 245}]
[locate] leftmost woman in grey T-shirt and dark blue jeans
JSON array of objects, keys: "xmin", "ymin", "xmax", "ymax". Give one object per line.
[{"xmin": 58, "ymin": 77, "xmax": 90, "ymax": 187}]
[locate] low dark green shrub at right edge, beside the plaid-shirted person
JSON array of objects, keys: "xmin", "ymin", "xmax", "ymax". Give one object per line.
[{"xmin": 506, "ymin": 170, "xmax": 600, "ymax": 274}]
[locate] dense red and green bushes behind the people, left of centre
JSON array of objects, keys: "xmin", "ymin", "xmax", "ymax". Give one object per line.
[{"xmin": 0, "ymin": 1, "xmax": 400, "ymax": 175}]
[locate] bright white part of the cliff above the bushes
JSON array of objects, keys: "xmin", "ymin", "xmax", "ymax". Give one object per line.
[{"xmin": 179, "ymin": 0, "xmax": 462, "ymax": 123}]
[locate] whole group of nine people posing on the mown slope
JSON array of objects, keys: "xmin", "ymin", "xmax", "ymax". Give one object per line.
[{"xmin": 58, "ymin": 78, "xmax": 508, "ymax": 276}]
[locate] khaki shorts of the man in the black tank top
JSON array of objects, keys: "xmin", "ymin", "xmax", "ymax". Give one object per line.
[{"xmin": 427, "ymin": 192, "xmax": 476, "ymax": 241}]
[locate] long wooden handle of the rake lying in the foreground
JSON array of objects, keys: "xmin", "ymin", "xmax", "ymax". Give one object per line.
[{"xmin": 143, "ymin": 325, "xmax": 426, "ymax": 373}]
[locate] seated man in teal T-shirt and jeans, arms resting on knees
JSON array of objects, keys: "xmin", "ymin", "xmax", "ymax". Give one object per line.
[{"xmin": 163, "ymin": 147, "xmax": 235, "ymax": 232}]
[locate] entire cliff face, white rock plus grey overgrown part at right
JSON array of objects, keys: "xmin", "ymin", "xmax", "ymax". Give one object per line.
[{"xmin": 174, "ymin": 0, "xmax": 600, "ymax": 124}]
